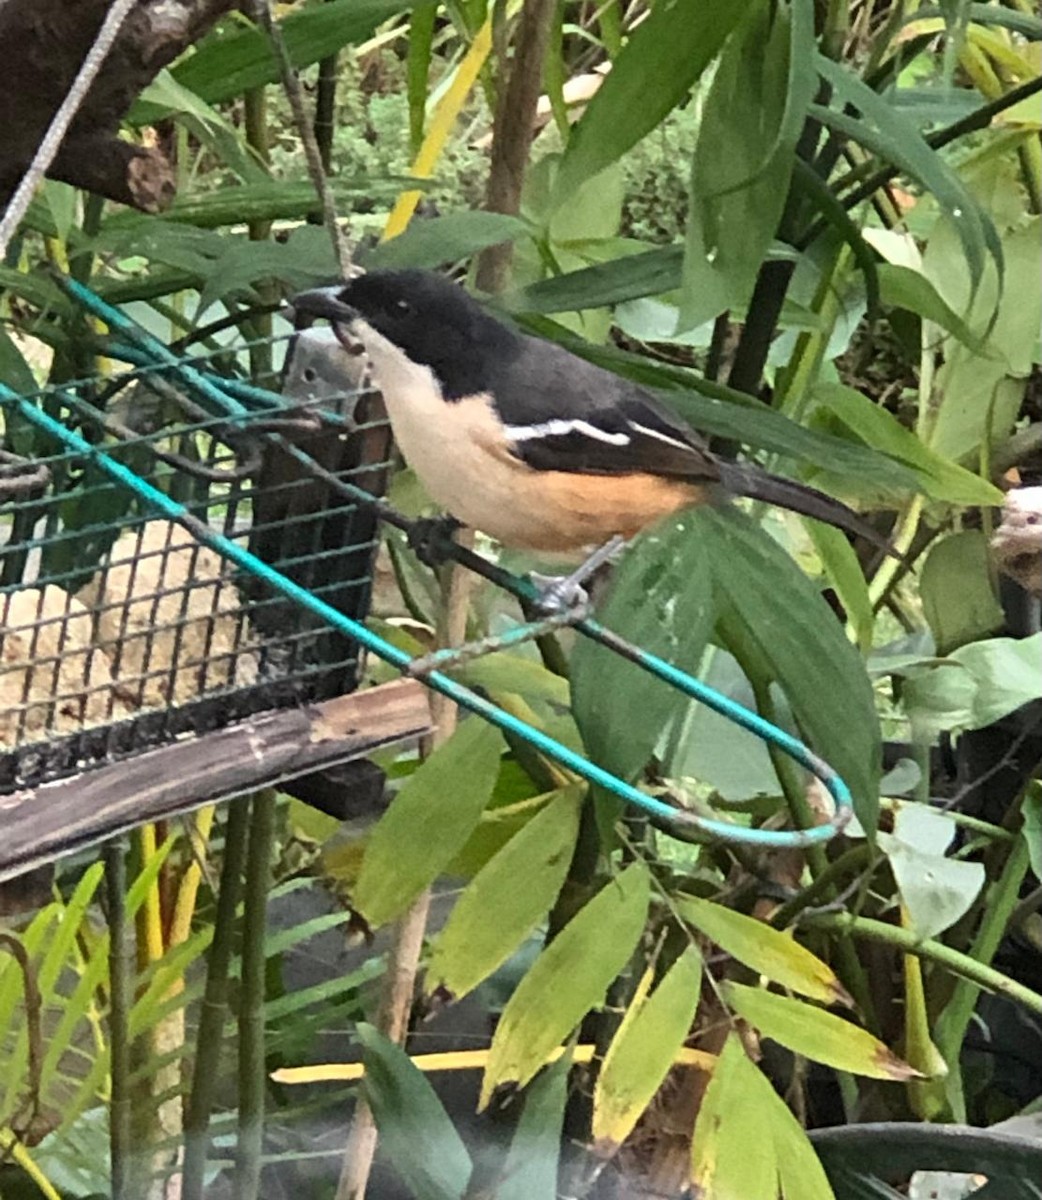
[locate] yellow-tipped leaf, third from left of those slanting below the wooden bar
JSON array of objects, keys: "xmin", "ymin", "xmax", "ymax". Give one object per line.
[{"xmin": 480, "ymin": 862, "xmax": 651, "ymax": 1108}]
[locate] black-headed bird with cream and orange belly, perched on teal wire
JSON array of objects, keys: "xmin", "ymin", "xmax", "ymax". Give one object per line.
[{"xmin": 289, "ymin": 269, "xmax": 881, "ymax": 595}]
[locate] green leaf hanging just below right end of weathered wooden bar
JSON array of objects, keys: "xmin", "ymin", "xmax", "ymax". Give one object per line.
[{"xmin": 353, "ymin": 718, "xmax": 503, "ymax": 925}]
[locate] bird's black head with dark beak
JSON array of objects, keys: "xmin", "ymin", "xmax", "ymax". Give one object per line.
[{"xmin": 293, "ymin": 270, "xmax": 516, "ymax": 400}]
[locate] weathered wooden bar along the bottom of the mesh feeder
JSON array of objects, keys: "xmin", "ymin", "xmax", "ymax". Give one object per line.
[{"xmin": 0, "ymin": 679, "xmax": 431, "ymax": 880}]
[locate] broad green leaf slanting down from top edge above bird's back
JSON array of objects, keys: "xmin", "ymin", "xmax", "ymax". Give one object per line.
[{"xmin": 555, "ymin": 0, "xmax": 748, "ymax": 205}]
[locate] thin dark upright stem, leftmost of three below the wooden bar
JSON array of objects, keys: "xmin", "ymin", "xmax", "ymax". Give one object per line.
[{"xmin": 104, "ymin": 838, "xmax": 133, "ymax": 1200}]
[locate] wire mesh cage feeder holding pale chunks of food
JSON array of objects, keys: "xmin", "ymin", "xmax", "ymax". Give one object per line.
[{"xmin": 0, "ymin": 331, "xmax": 390, "ymax": 793}]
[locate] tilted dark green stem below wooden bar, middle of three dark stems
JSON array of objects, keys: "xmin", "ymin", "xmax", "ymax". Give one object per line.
[{"xmin": 181, "ymin": 797, "xmax": 250, "ymax": 1200}]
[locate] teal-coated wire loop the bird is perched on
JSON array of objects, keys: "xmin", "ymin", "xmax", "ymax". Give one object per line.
[{"xmin": 0, "ymin": 280, "xmax": 852, "ymax": 847}]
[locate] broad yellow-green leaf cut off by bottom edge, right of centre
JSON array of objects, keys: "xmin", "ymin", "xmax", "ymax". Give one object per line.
[{"xmin": 691, "ymin": 1033, "xmax": 836, "ymax": 1200}]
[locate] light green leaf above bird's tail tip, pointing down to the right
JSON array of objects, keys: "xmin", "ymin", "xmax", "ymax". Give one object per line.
[{"xmin": 814, "ymin": 383, "xmax": 1002, "ymax": 505}]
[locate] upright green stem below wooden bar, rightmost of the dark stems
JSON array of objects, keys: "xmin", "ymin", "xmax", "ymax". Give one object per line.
[{"xmin": 235, "ymin": 787, "xmax": 276, "ymax": 1200}]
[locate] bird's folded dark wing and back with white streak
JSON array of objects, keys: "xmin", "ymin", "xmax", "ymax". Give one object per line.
[{"xmin": 490, "ymin": 337, "xmax": 720, "ymax": 481}]
